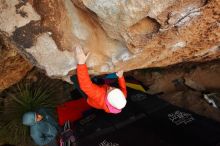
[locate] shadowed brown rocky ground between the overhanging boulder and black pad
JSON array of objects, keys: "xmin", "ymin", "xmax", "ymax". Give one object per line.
[{"xmin": 128, "ymin": 60, "xmax": 220, "ymax": 121}]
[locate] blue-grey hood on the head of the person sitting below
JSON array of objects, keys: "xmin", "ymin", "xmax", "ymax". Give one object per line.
[{"xmin": 22, "ymin": 112, "xmax": 36, "ymax": 126}]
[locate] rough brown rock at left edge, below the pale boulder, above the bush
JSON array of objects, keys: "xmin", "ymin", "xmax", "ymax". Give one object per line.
[{"xmin": 0, "ymin": 32, "xmax": 32, "ymax": 92}]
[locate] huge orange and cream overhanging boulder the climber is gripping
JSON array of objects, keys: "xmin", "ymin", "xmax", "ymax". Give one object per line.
[{"xmin": 0, "ymin": 0, "xmax": 220, "ymax": 78}]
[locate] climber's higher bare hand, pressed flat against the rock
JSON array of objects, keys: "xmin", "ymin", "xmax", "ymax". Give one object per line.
[{"xmin": 75, "ymin": 46, "xmax": 90, "ymax": 64}]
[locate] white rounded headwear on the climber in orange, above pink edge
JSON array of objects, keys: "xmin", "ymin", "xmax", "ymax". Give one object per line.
[{"xmin": 107, "ymin": 88, "xmax": 127, "ymax": 110}]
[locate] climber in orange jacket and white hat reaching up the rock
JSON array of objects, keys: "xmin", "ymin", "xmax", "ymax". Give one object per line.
[{"xmin": 75, "ymin": 47, "xmax": 127, "ymax": 114}]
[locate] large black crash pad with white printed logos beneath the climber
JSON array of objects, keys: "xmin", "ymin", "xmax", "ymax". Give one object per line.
[{"xmin": 77, "ymin": 88, "xmax": 220, "ymax": 146}]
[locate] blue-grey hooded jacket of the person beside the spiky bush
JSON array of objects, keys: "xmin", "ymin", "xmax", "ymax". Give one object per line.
[{"xmin": 23, "ymin": 109, "xmax": 58, "ymax": 146}]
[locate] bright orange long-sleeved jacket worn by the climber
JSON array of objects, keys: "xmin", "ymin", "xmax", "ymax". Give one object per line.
[{"xmin": 77, "ymin": 64, "xmax": 127, "ymax": 113}]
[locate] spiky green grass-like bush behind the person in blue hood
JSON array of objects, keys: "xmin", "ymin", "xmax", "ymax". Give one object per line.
[{"xmin": 0, "ymin": 78, "xmax": 61, "ymax": 146}]
